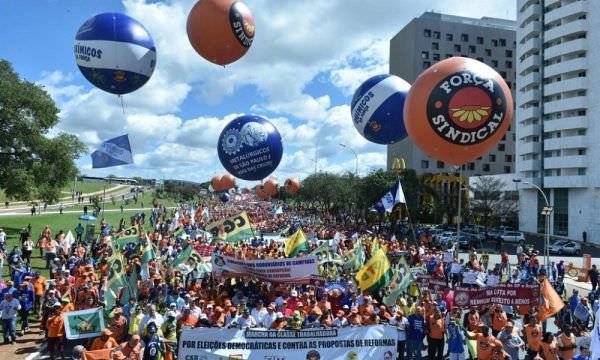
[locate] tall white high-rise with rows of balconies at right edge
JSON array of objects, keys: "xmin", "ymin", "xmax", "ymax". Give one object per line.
[{"xmin": 515, "ymin": 0, "xmax": 600, "ymax": 242}]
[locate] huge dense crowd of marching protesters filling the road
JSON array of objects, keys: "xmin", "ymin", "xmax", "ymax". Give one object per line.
[{"xmin": 0, "ymin": 197, "xmax": 598, "ymax": 360}]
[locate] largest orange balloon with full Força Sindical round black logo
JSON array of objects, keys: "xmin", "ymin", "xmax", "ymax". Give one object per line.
[{"xmin": 404, "ymin": 57, "xmax": 513, "ymax": 165}]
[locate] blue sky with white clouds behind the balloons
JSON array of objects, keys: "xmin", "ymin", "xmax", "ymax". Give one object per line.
[{"xmin": 0, "ymin": 0, "xmax": 516, "ymax": 185}]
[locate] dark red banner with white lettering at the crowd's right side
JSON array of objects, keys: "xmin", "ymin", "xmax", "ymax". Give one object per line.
[{"xmin": 454, "ymin": 284, "xmax": 540, "ymax": 307}]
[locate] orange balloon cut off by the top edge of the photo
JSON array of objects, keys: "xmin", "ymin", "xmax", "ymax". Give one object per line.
[{"xmin": 187, "ymin": 0, "xmax": 254, "ymax": 65}]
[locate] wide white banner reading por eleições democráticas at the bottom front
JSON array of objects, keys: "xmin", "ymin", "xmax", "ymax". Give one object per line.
[{"xmin": 178, "ymin": 325, "xmax": 398, "ymax": 360}]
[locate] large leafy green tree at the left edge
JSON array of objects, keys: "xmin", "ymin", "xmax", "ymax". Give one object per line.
[{"xmin": 0, "ymin": 60, "xmax": 87, "ymax": 203}]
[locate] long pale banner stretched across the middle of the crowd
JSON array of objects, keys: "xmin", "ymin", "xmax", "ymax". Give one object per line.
[{"xmin": 212, "ymin": 255, "xmax": 318, "ymax": 284}]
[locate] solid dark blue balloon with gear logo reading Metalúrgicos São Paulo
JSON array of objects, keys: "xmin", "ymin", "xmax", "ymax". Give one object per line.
[{"xmin": 217, "ymin": 115, "xmax": 283, "ymax": 181}]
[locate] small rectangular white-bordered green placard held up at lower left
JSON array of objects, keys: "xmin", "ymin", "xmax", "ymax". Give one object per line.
[{"xmin": 63, "ymin": 308, "xmax": 104, "ymax": 340}]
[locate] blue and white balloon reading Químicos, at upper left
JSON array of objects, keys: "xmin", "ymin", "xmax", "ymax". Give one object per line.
[{"xmin": 75, "ymin": 13, "xmax": 156, "ymax": 95}]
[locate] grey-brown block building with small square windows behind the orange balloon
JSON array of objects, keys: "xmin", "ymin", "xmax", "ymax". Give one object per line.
[{"xmin": 387, "ymin": 12, "xmax": 516, "ymax": 176}]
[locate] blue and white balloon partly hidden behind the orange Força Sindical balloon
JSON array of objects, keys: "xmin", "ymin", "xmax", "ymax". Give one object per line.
[{"xmin": 351, "ymin": 74, "xmax": 410, "ymax": 145}]
